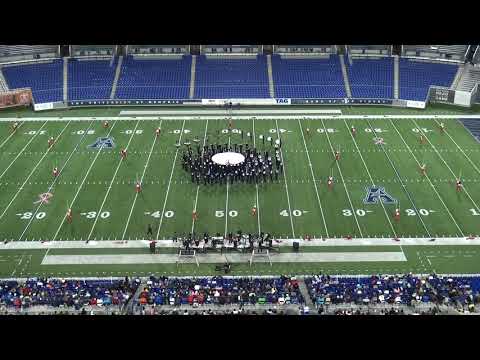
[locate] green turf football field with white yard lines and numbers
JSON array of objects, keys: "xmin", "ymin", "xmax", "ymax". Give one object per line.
[{"xmin": 0, "ymin": 108, "xmax": 480, "ymax": 277}]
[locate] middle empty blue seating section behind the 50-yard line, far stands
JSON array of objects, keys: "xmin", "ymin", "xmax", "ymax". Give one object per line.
[{"xmin": 195, "ymin": 55, "xmax": 270, "ymax": 99}]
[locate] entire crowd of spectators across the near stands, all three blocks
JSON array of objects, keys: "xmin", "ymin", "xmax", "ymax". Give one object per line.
[{"xmin": 0, "ymin": 273, "xmax": 480, "ymax": 315}]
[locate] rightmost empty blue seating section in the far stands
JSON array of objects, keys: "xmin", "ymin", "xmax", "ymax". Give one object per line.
[{"xmin": 399, "ymin": 59, "xmax": 458, "ymax": 101}]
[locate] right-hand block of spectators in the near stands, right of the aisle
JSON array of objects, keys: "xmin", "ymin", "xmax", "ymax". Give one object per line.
[{"xmin": 305, "ymin": 273, "xmax": 480, "ymax": 309}]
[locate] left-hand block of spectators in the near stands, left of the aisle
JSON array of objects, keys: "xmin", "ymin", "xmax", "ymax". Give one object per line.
[{"xmin": 0, "ymin": 278, "xmax": 140, "ymax": 310}]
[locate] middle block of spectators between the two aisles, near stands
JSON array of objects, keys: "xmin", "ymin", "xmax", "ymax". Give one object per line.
[{"xmin": 138, "ymin": 276, "xmax": 304, "ymax": 307}]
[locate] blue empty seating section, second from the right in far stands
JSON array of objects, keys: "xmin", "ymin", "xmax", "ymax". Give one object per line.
[{"xmin": 345, "ymin": 57, "xmax": 393, "ymax": 99}]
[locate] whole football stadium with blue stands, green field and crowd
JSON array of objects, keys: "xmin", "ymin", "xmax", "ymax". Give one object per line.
[{"xmin": 0, "ymin": 45, "xmax": 480, "ymax": 315}]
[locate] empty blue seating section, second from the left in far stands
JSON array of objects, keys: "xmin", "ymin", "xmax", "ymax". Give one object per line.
[{"xmin": 68, "ymin": 59, "xmax": 117, "ymax": 100}]
